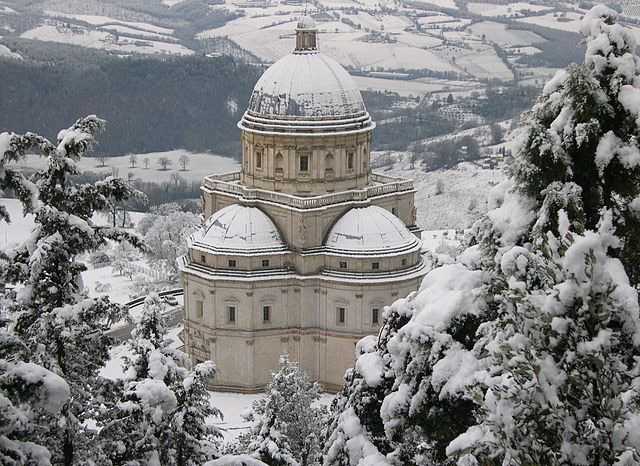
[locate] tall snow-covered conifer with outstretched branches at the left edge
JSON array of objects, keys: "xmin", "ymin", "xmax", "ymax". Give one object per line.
[{"xmin": 0, "ymin": 116, "xmax": 140, "ymax": 465}]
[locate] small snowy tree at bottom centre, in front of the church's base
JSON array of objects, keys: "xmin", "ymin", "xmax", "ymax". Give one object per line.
[{"xmin": 241, "ymin": 355, "xmax": 325, "ymax": 466}]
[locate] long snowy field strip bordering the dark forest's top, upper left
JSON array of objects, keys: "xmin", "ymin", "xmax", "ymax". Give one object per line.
[{"xmin": 20, "ymin": 24, "xmax": 193, "ymax": 55}]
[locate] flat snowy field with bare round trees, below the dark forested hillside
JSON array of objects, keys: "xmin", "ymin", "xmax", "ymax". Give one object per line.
[{"xmin": 11, "ymin": 150, "xmax": 240, "ymax": 183}]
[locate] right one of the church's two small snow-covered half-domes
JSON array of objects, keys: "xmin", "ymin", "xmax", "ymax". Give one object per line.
[{"xmin": 325, "ymin": 206, "xmax": 420, "ymax": 255}]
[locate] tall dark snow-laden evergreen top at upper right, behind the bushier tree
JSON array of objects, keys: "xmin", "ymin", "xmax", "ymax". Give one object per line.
[{"xmin": 512, "ymin": 7, "xmax": 640, "ymax": 284}]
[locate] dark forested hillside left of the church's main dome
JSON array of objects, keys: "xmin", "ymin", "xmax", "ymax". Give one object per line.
[{"xmin": 0, "ymin": 48, "xmax": 259, "ymax": 155}]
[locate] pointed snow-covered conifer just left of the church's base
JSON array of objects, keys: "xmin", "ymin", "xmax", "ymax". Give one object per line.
[{"xmin": 99, "ymin": 294, "xmax": 222, "ymax": 466}]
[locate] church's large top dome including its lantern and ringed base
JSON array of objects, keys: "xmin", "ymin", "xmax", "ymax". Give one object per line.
[{"xmin": 238, "ymin": 17, "xmax": 375, "ymax": 135}]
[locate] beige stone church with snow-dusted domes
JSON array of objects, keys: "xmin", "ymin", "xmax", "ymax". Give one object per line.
[{"xmin": 179, "ymin": 17, "xmax": 426, "ymax": 392}]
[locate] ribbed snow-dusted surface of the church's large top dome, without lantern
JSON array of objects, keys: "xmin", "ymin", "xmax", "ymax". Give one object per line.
[{"xmin": 248, "ymin": 52, "xmax": 366, "ymax": 118}]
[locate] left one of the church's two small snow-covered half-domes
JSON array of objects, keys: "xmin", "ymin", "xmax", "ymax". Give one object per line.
[{"xmin": 191, "ymin": 204, "xmax": 286, "ymax": 253}]
